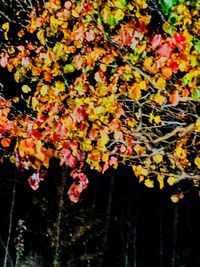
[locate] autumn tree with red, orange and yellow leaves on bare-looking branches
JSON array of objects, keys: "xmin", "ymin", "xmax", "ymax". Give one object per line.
[{"xmin": 0, "ymin": 0, "xmax": 200, "ymax": 205}]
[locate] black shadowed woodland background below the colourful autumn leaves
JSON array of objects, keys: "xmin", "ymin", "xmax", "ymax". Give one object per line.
[{"xmin": 0, "ymin": 160, "xmax": 200, "ymax": 267}]
